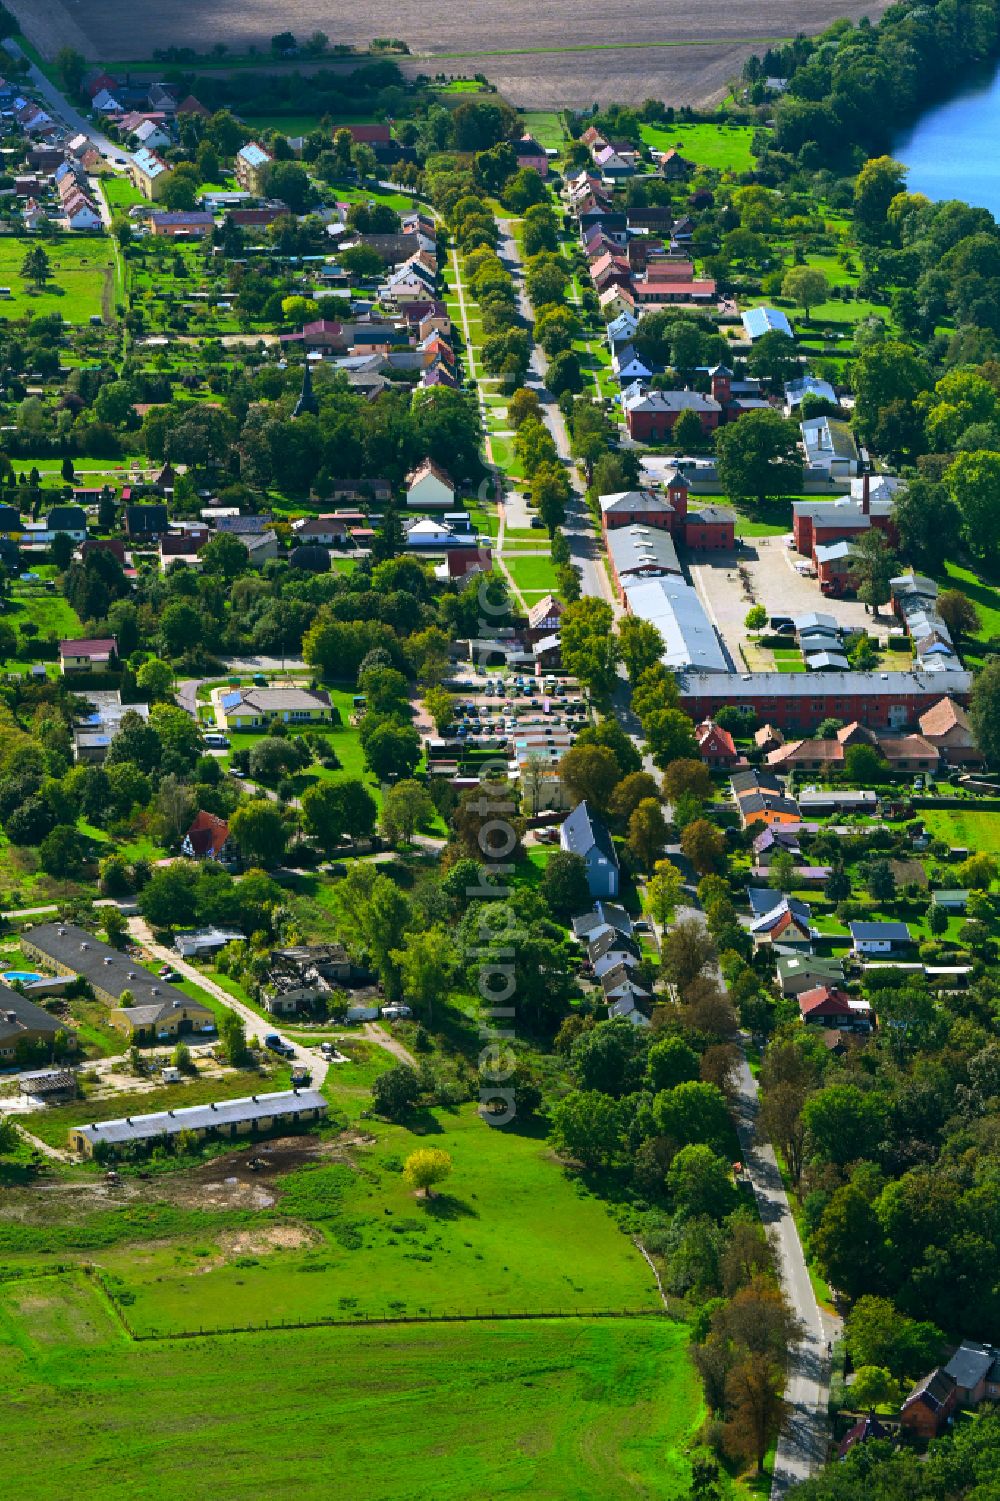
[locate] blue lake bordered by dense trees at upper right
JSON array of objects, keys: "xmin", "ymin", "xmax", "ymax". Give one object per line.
[{"xmin": 892, "ymin": 69, "xmax": 1000, "ymax": 219}]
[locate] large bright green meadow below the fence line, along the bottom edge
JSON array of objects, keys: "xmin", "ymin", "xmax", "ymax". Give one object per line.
[{"xmin": 0, "ymin": 1276, "xmax": 703, "ymax": 1501}]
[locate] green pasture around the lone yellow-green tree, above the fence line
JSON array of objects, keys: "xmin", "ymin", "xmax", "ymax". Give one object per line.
[{"xmin": 101, "ymin": 1098, "xmax": 656, "ymax": 1331}]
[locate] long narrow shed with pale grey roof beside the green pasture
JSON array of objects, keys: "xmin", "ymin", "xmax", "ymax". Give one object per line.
[{"xmin": 69, "ymin": 1090, "xmax": 327, "ymax": 1157}]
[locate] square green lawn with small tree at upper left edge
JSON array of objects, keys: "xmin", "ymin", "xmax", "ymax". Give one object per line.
[{"xmin": 0, "ymin": 236, "xmax": 114, "ymax": 323}]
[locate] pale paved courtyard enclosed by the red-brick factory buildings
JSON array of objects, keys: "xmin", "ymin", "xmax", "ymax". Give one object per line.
[{"xmin": 691, "ymin": 536, "xmax": 890, "ymax": 668}]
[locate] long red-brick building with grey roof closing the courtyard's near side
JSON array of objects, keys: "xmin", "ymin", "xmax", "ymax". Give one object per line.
[{"xmin": 677, "ymin": 666, "xmax": 971, "ymax": 734}]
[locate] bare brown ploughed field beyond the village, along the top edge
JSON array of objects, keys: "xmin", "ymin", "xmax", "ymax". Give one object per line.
[{"xmin": 12, "ymin": 0, "xmax": 884, "ymax": 110}]
